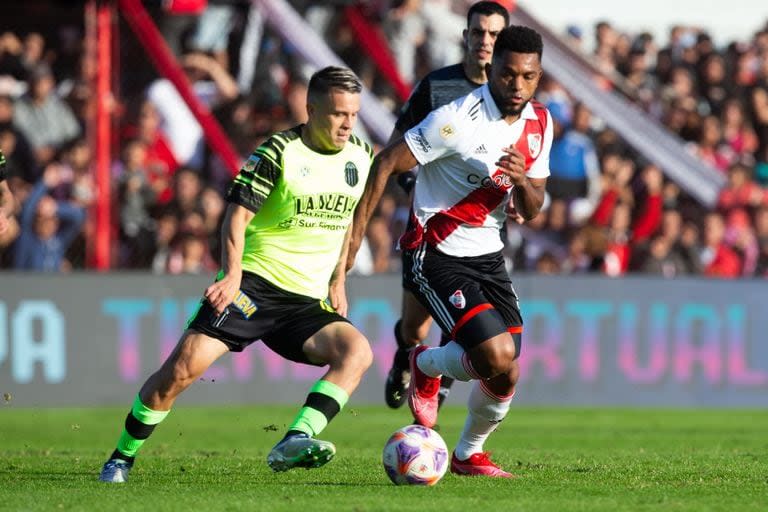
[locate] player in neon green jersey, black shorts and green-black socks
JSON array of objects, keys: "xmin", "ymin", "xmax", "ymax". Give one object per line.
[{"xmin": 99, "ymin": 67, "xmax": 373, "ymax": 482}]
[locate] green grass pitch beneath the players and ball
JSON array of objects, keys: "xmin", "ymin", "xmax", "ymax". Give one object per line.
[{"xmin": 0, "ymin": 403, "xmax": 768, "ymax": 512}]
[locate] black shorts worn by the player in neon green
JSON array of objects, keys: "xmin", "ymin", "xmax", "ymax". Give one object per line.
[{"xmin": 187, "ymin": 272, "xmax": 349, "ymax": 366}]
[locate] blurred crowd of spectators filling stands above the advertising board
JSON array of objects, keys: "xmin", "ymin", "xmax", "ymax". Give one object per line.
[{"xmin": 0, "ymin": 0, "xmax": 768, "ymax": 278}]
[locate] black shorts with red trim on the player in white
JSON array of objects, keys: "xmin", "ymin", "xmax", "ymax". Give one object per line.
[{"xmin": 403, "ymin": 244, "xmax": 523, "ymax": 357}]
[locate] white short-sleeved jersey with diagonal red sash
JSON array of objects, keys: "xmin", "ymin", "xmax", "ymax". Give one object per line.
[{"xmin": 400, "ymin": 84, "xmax": 552, "ymax": 256}]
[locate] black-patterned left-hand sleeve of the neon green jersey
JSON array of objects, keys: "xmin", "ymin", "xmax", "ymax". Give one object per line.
[{"xmin": 227, "ymin": 139, "xmax": 282, "ymax": 213}]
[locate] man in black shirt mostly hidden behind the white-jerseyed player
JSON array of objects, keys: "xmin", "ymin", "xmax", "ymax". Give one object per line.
[{"xmin": 384, "ymin": 2, "xmax": 509, "ymax": 409}]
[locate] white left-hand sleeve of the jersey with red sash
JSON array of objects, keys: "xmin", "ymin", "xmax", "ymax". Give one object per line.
[{"xmin": 404, "ymin": 103, "xmax": 460, "ymax": 165}]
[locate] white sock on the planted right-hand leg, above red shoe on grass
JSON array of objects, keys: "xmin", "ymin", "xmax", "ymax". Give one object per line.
[{"xmin": 454, "ymin": 380, "xmax": 514, "ymax": 460}]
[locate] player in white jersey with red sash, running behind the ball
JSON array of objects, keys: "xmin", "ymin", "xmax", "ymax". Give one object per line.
[{"xmin": 347, "ymin": 26, "xmax": 552, "ymax": 477}]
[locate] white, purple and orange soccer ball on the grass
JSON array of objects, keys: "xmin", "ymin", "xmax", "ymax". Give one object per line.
[{"xmin": 382, "ymin": 425, "xmax": 448, "ymax": 485}]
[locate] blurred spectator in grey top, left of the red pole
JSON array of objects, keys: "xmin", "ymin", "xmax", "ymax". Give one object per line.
[{"xmin": 13, "ymin": 64, "xmax": 80, "ymax": 165}]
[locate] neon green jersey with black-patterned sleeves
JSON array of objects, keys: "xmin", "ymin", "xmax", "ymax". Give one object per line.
[{"xmin": 227, "ymin": 125, "xmax": 373, "ymax": 299}]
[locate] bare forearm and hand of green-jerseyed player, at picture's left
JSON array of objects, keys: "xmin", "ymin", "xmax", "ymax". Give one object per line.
[{"xmin": 205, "ymin": 203, "xmax": 255, "ymax": 314}]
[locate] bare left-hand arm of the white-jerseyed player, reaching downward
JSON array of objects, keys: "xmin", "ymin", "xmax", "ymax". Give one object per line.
[{"xmin": 347, "ymin": 138, "xmax": 419, "ymax": 270}]
